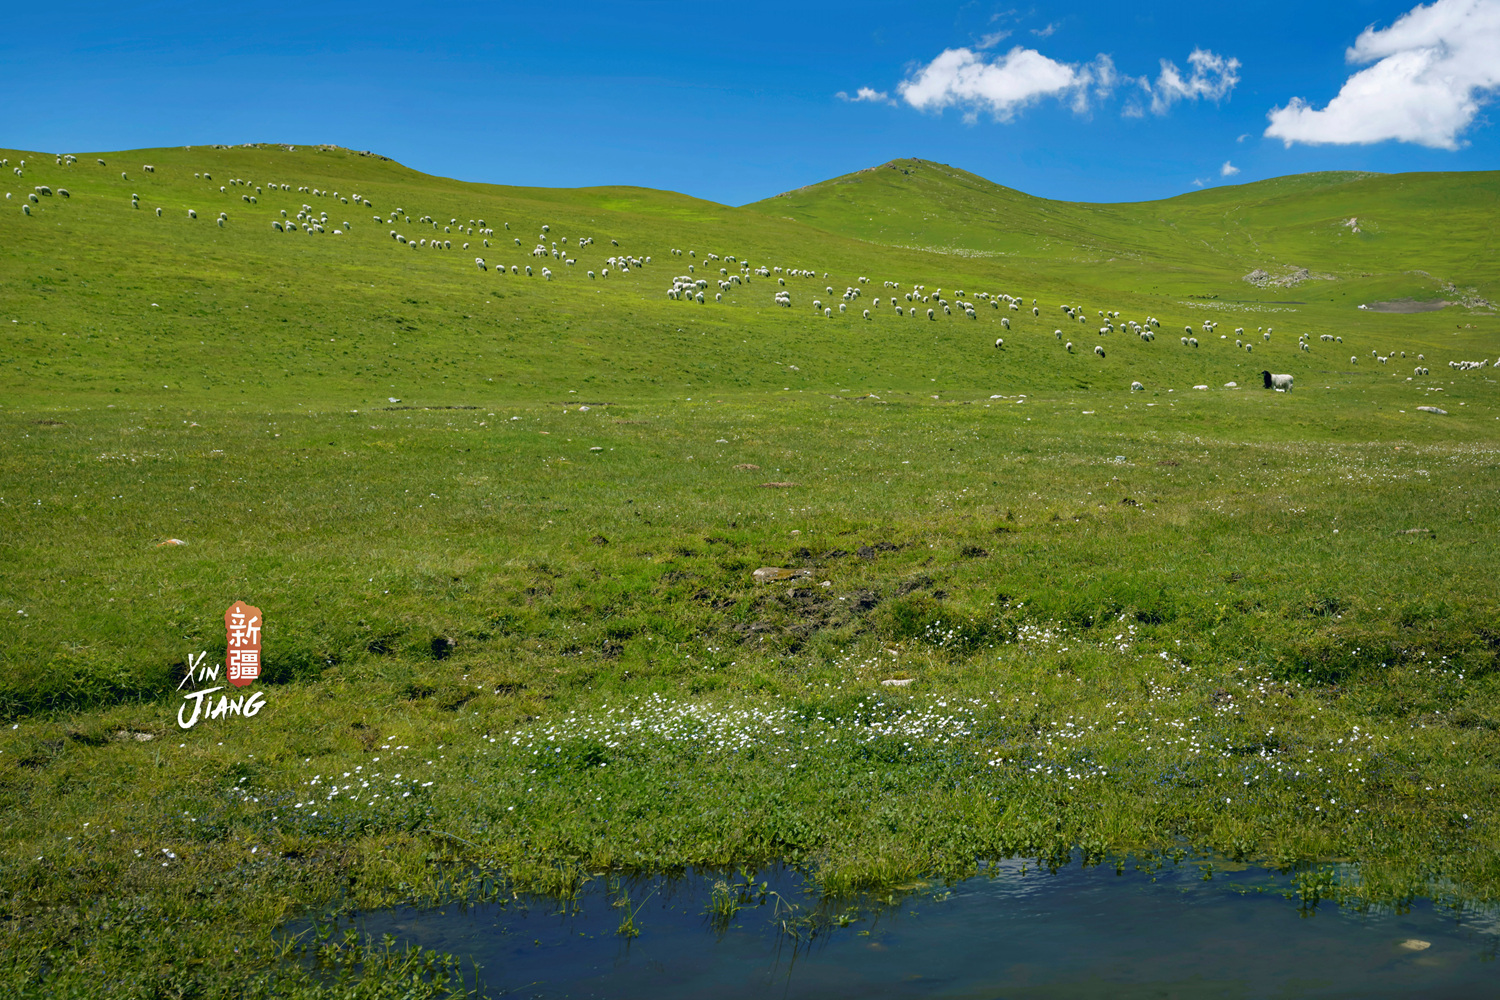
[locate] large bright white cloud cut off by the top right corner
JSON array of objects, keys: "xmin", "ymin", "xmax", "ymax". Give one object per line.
[{"xmin": 1266, "ymin": 0, "xmax": 1500, "ymax": 150}]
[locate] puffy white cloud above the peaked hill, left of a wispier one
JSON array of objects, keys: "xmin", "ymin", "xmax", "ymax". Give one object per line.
[{"xmin": 897, "ymin": 45, "xmax": 1118, "ymax": 121}]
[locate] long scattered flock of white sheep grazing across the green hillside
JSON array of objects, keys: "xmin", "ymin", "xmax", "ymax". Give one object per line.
[{"xmin": 0, "ymin": 154, "xmax": 1500, "ymax": 391}]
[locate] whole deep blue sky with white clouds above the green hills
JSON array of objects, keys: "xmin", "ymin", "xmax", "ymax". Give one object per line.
[{"xmin": 0, "ymin": 0, "xmax": 1500, "ymax": 204}]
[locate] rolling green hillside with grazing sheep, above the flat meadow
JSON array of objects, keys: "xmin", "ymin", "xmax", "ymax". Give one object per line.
[{"xmin": 0, "ymin": 144, "xmax": 1500, "ymax": 410}]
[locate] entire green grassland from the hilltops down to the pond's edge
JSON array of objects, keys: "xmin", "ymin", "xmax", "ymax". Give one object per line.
[{"xmin": 0, "ymin": 145, "xmax": 1500, "ymax": 996}]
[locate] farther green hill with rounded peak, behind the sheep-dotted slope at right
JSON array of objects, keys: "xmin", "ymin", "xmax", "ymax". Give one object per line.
[{"xmin": 747, "ymin": 159, "xmax": 1500, "ymax": 297}]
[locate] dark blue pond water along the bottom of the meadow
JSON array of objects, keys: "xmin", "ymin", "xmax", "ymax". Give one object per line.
[{"xmin": 334, "ymin": 862, "xmax": 1500, "ymax": 1000}]
